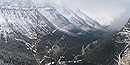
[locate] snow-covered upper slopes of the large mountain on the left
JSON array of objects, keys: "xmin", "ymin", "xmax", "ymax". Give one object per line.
[{"xmin": 0, "ymin": 0, "xmax": 103, "ymax": 38}]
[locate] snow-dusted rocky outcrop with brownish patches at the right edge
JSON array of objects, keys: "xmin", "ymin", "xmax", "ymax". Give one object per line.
[{"xmin": 114, "ymin": 19, "xmax": 130, "ymax": 65}]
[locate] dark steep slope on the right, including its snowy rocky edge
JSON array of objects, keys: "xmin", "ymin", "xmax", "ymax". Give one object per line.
[{"xmin": 84, "ymin": 19, "xmax": 130, "ymax": 65}]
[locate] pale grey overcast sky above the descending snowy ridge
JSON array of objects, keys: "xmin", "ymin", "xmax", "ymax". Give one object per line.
[{"xmin": 57, "ymin": 0, "xmax": 130, "ymax": 28}]
